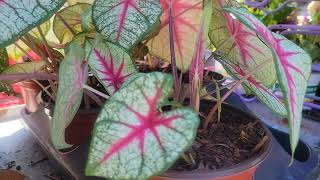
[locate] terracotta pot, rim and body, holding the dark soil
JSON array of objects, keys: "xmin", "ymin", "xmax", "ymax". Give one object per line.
[{"xmin": 151, "ymin": 101, "xmax": 272, "ymax": 180}]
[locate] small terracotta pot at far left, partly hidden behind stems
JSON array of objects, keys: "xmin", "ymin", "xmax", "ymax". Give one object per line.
[{"xmin": 18, "ymin": 81, "xmax": 41, "ymax": 113}]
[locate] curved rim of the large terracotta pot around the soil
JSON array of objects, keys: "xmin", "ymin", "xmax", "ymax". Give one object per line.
[{"xmin": 161, "ymin": 103, "xmax": 272, "ymax": 179}]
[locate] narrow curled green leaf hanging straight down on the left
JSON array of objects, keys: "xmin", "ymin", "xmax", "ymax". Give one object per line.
[{"xmin": 51, "ymin": 43, "xmax": 88, "ymax": 149}]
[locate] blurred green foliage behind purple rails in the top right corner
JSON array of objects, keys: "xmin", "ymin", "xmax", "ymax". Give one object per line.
[{"xmin": 246, "ymin": 0, "xmax": 320, "ymax": 63}]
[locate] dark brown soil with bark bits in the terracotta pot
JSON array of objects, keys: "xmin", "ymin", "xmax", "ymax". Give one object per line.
[{"xmin": 171, "ymin": 101, "xmax": 267, "ymax": 171}]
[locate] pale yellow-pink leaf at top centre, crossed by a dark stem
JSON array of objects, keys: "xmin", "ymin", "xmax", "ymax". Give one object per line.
[{"xmin": 148, "ymin": 0, "xmax": 202, "ymax": 72}]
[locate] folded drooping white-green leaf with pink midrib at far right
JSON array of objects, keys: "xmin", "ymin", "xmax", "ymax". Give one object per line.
[{"xmin": 224, "ymin": 7, "xmax": 311, "ymax": 159}]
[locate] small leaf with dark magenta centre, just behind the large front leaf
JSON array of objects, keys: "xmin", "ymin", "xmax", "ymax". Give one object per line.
[{"xmin": 86, "ymin": 36, "xmax": 137, "ymax": 94}]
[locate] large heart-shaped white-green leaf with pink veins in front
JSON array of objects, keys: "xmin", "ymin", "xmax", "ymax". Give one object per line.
[{"xmin": 86, "ymin": 72, "xmax": 199, "ymax": 180}]
